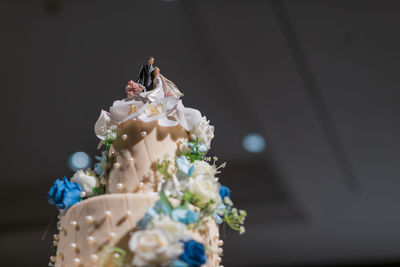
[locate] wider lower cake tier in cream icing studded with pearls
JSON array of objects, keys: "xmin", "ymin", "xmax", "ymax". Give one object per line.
[{"xmin": 56, "ymin": 193, "xmax": 222, "ymax": 267}]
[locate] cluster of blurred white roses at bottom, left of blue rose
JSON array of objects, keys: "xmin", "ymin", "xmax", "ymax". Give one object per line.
[{"xmin": 129, "ymin": 216, "xmax": 190, "ymax": 267}]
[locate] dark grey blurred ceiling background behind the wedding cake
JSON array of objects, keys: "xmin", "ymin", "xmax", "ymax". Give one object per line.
[{"xmin": 0, "ymin": 0, "xmax": 400, "ymax": 267}]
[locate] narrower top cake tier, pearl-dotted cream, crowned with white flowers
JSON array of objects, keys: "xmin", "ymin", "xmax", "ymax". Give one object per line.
[{"xmin": 95, "ymin": 86, "xmax": 214, "ymax": 197}]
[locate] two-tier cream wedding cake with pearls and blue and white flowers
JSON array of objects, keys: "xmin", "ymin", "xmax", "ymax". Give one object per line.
[{"xmin": 48, "ymin": 61, "xmax": 246, "ymax": 267}]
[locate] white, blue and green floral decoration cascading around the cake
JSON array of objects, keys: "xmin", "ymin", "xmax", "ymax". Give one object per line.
[{"xmin": 48, "ymin": 57, "xmax": 246, "ymax": 267}]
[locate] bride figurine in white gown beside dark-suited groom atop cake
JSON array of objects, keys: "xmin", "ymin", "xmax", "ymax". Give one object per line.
[{"xmin": 140, "ymin": 67, "xmax": 183, "ymax": 102}]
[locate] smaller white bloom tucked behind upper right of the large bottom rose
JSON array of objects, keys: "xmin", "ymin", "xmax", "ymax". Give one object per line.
[{"xmin": 152, "ymin": 216, "xmax": 190, "ymax": 243}]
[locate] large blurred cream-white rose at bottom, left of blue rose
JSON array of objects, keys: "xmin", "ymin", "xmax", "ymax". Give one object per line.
[{"xmin": 128, "ymin": 229, "xmax": 183, "ymax": 267}]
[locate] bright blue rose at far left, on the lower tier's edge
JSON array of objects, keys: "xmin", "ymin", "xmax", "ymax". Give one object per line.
[{"xmin": 47, "ymin": 177, "xmax": 82, "ymax": 209}]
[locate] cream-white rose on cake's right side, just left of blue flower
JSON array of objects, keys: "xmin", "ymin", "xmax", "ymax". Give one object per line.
[{"xmin": 187, "ymin": 175, "xmax": 220, "ymax": 205}]
